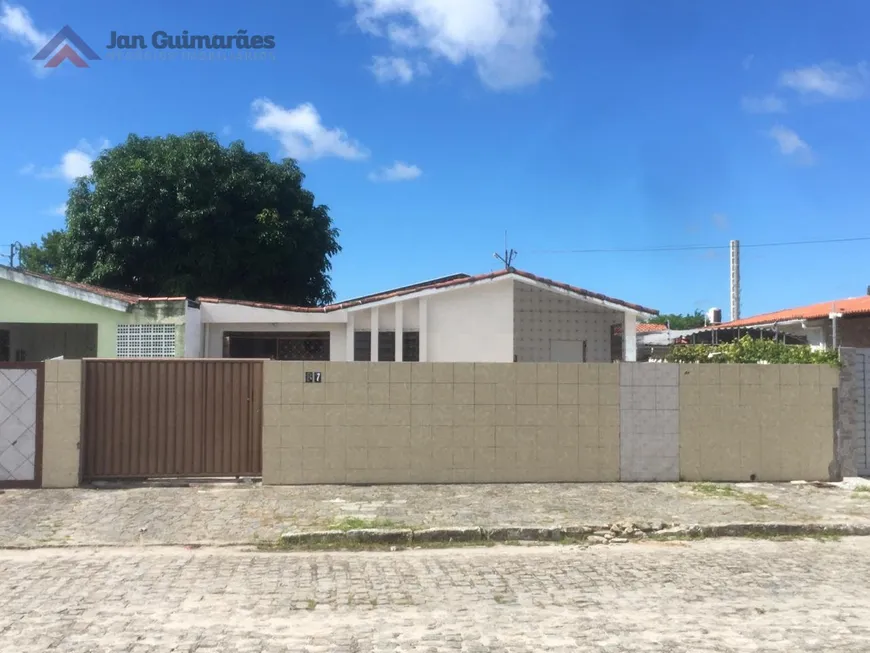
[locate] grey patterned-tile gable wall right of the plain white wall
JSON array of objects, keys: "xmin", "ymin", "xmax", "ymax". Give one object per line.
[{"xmin": 513, "ymin": 281, "xmax": 623, "ymax": 363}]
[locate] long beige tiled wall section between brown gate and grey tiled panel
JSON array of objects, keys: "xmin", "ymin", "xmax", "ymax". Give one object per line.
[{"xmin": 263, "ymin": 362, "xmax": 619, "ymax": 484}]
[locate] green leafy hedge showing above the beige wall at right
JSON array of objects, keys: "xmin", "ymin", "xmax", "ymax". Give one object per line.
[{"xmin": 665, "ymin": 335, "xmax": 840, "ymax": 366}]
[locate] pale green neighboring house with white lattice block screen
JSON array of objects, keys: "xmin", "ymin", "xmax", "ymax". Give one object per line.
[{"xmin": 0, "ymin": 266, "xmax": 199, "ymax": 361}]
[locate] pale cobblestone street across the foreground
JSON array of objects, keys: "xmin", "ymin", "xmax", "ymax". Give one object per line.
[{"xmin": 0, "ymin": 538, "xmax": 870, "ymax": 653}]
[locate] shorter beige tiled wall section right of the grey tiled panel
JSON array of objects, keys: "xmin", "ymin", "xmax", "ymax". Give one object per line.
[{"xmin": 679, "ymin": 365, "xmax": 839, "ymax": 481}]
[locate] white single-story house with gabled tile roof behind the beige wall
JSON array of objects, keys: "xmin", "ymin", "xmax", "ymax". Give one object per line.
[{"xmin": 194, "ymin": 270, "xmax": 657, "ymax": 362}]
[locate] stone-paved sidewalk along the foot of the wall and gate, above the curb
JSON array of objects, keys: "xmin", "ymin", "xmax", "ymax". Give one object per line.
[{"xmin": 0, "ymin": 482, "xmax": 870, "ymax": 547}]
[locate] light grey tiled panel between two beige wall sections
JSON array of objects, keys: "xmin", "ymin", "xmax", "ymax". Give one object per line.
[{"xmin": 619, "ymin": 363, "xmax": 680, "ymax": 481}]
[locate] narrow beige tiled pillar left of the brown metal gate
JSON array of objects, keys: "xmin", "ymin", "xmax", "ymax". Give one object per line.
[{"xmin": 42, "ymin": 360, "xmax": 82, "ymax": 488}]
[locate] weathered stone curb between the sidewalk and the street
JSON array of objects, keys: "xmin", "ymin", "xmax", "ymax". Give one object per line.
[{"xmin": 281, "ymin": 522, "xmax": 870, "ymax": 546}]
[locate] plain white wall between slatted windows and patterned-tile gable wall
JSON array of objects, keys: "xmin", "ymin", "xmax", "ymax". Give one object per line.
[{"xmin": 426, "ymin": 279, "xmax": 514, "ymax": 363}]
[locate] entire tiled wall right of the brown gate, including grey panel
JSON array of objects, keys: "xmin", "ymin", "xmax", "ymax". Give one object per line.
[{"xmin": 263, "ymin": 362, "xmax": 838, "ymax": 484}]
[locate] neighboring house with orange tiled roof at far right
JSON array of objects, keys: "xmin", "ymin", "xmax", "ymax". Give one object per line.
[{"xmin": 719, "ymin": 295, "xmax": 870, "ymax": 348}]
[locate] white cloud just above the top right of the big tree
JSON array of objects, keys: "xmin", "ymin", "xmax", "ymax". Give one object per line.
[{"xmin": 251, "ymin": 98, "xmax": 368, "ymax": 161}]
